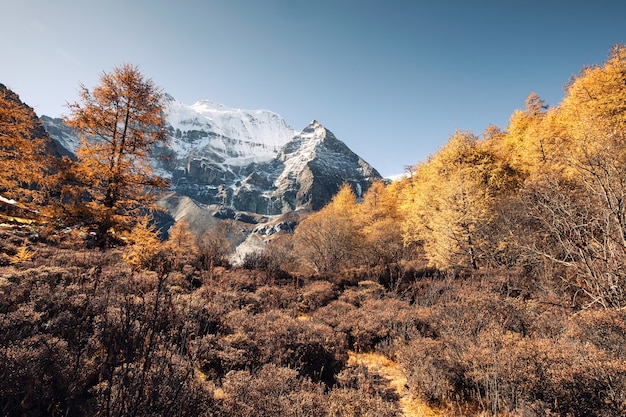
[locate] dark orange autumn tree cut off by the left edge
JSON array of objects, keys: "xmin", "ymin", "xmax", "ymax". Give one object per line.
[{"xmin": 0, "ymin": 84, "xmax": 47, "ymax": 199}]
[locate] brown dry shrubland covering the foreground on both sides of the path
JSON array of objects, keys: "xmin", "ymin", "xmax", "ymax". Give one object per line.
[{"xmin": 0, "ymin": 224, "xmax": 626, "ymax": 417}]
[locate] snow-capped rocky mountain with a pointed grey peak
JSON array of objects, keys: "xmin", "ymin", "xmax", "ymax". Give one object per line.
[{"xmin": 41, "ymin": 97, "xmax": 381, "ymax": 215}]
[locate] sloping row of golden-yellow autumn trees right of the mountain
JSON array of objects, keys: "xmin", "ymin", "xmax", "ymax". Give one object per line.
[{"xmin": 294, "ymin": 46, "xmax": 626, "ymax": 309}]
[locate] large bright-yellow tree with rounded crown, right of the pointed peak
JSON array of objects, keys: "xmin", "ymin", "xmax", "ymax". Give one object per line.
[{"xmin": 401, "ymin": 131, "xmax": 517, "ymax": 269}]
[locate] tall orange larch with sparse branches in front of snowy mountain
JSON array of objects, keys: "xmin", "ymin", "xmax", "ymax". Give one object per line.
[{"xmin": 66, "ymin": 64, "xmax": 167, "ymax": 244}]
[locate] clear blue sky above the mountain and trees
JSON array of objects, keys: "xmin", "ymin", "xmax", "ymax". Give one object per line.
[{"xmin": 0, "ymin": 0, "xmax": 626, "ymax": 175}]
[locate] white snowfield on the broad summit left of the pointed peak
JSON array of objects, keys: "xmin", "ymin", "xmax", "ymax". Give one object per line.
[{"xmin": 166, "ymin": 98, "xmax": 297, "ymax": 167}]
